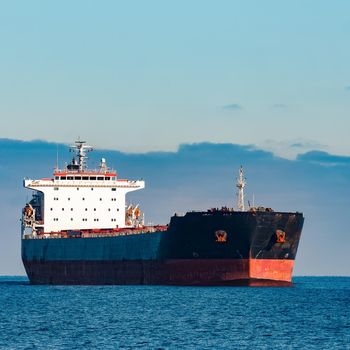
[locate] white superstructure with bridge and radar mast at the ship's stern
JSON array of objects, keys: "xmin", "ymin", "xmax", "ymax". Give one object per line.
[{"xmin": 22, "ymin": 141, "xmax": 145, "ymax": 235}]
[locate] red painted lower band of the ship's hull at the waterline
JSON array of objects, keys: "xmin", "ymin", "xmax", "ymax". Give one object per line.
[{"xmin": 24, "ymin": 259, "xmax": 294, "ymax": 286}]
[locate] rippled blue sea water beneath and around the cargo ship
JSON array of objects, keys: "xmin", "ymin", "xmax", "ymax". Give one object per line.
[{"xmin": 0, "ymin": 277, "xmax": 350, "ymax": 349}]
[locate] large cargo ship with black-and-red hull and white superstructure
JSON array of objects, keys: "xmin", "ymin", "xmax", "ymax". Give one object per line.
[{"xmin": 21, "ymin": 141, "xmax": 304, "ymax": 286}]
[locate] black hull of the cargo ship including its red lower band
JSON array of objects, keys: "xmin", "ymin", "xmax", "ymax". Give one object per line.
[{"xmin": 22, "ymin": 211, "xmax": 304, "ymax": 285}]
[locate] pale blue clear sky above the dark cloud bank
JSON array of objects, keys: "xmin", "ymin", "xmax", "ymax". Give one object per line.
[{"xmin": 0, "ymin": 0, "xmax": 350, "ymax": 159}]
